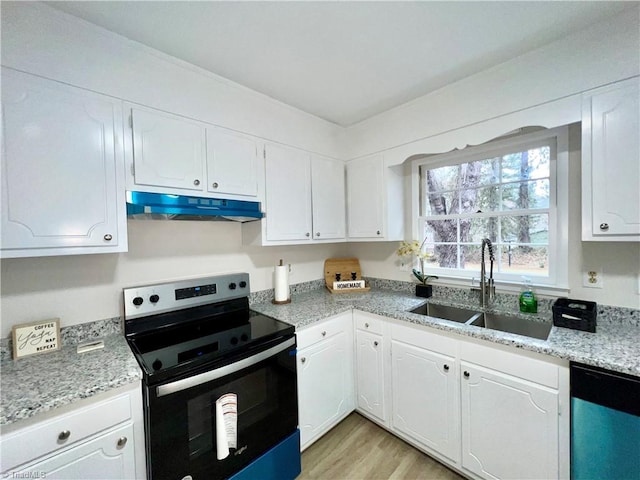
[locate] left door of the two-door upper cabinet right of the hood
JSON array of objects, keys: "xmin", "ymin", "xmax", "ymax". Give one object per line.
[{"xmin": 265, "ymin": 145, "xmax": 311, "ymax": 241}]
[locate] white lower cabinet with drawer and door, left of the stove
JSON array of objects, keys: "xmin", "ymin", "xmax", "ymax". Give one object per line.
[{"xmin": 0, "ymin": 382, "xmax": 146, "ymax": 480}]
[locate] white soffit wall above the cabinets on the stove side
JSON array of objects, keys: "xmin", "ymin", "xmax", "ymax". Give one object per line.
[{"xmin": 1, "ymin": 2, "xmax": 342, "ymax": 158}]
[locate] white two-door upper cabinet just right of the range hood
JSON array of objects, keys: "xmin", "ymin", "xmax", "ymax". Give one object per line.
[{"xmin": 243, "ymin": 144, "xmax": 345, "ymax": 245}]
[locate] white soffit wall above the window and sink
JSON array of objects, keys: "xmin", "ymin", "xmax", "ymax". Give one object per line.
[{"xmin": 343, "ymin": 5, "xmax": 640, "ymax": 159}]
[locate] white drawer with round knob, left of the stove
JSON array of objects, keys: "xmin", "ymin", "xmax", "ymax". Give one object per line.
[{"xmin": 0, "ymin": 395, "xmax": 132, "ymax": 472}]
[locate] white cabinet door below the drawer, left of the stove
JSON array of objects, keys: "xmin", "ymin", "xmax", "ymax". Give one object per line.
[{"xmin": 13, "ymin": 425, "xmax": 136, "ymax": 480}]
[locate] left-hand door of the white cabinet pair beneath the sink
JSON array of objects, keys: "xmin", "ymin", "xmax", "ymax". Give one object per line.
[{"xmin": 391, "ymin": 341, "xmax": 460, "ymax": 462}]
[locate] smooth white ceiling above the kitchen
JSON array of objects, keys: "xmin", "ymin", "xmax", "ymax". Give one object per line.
[{"xmin": 46, "ymin": 1, "xmax": 638, "ymax": 126}]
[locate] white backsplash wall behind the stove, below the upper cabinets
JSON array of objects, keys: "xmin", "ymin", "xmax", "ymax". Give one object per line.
[{"xmin": 0, "ymin": 220, "xmax": 345, "ymax": 337}]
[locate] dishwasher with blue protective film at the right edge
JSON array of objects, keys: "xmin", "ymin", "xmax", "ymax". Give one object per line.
[{"xmin": 571, "ymin": 363, "xmax": 640, "ymax": 480}]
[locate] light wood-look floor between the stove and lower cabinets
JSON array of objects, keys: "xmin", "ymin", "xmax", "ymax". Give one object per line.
[{"xmin": 297, "ymin": 413, "xmax": 464, "ymax": 480}]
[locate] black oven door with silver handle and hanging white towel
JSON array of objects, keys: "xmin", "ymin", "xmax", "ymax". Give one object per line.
[{"xmin": 146, "ymin": 337, "xmax": 299, "ymax": 480}]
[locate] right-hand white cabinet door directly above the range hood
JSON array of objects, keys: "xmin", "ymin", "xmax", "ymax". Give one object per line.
[{"xmin": 207, "ymin": 128, "xmax": 258, "ymax": 197}]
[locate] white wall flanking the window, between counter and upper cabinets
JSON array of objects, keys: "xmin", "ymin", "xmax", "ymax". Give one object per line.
[{"xmin": 347, "ymin": 124, "xmax": 640, "ymax": 308}]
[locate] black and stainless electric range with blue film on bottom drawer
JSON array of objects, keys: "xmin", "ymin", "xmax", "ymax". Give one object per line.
[{"xmin": 124, "ymin": 273, "xmax": 300, "ymax": 480}]
